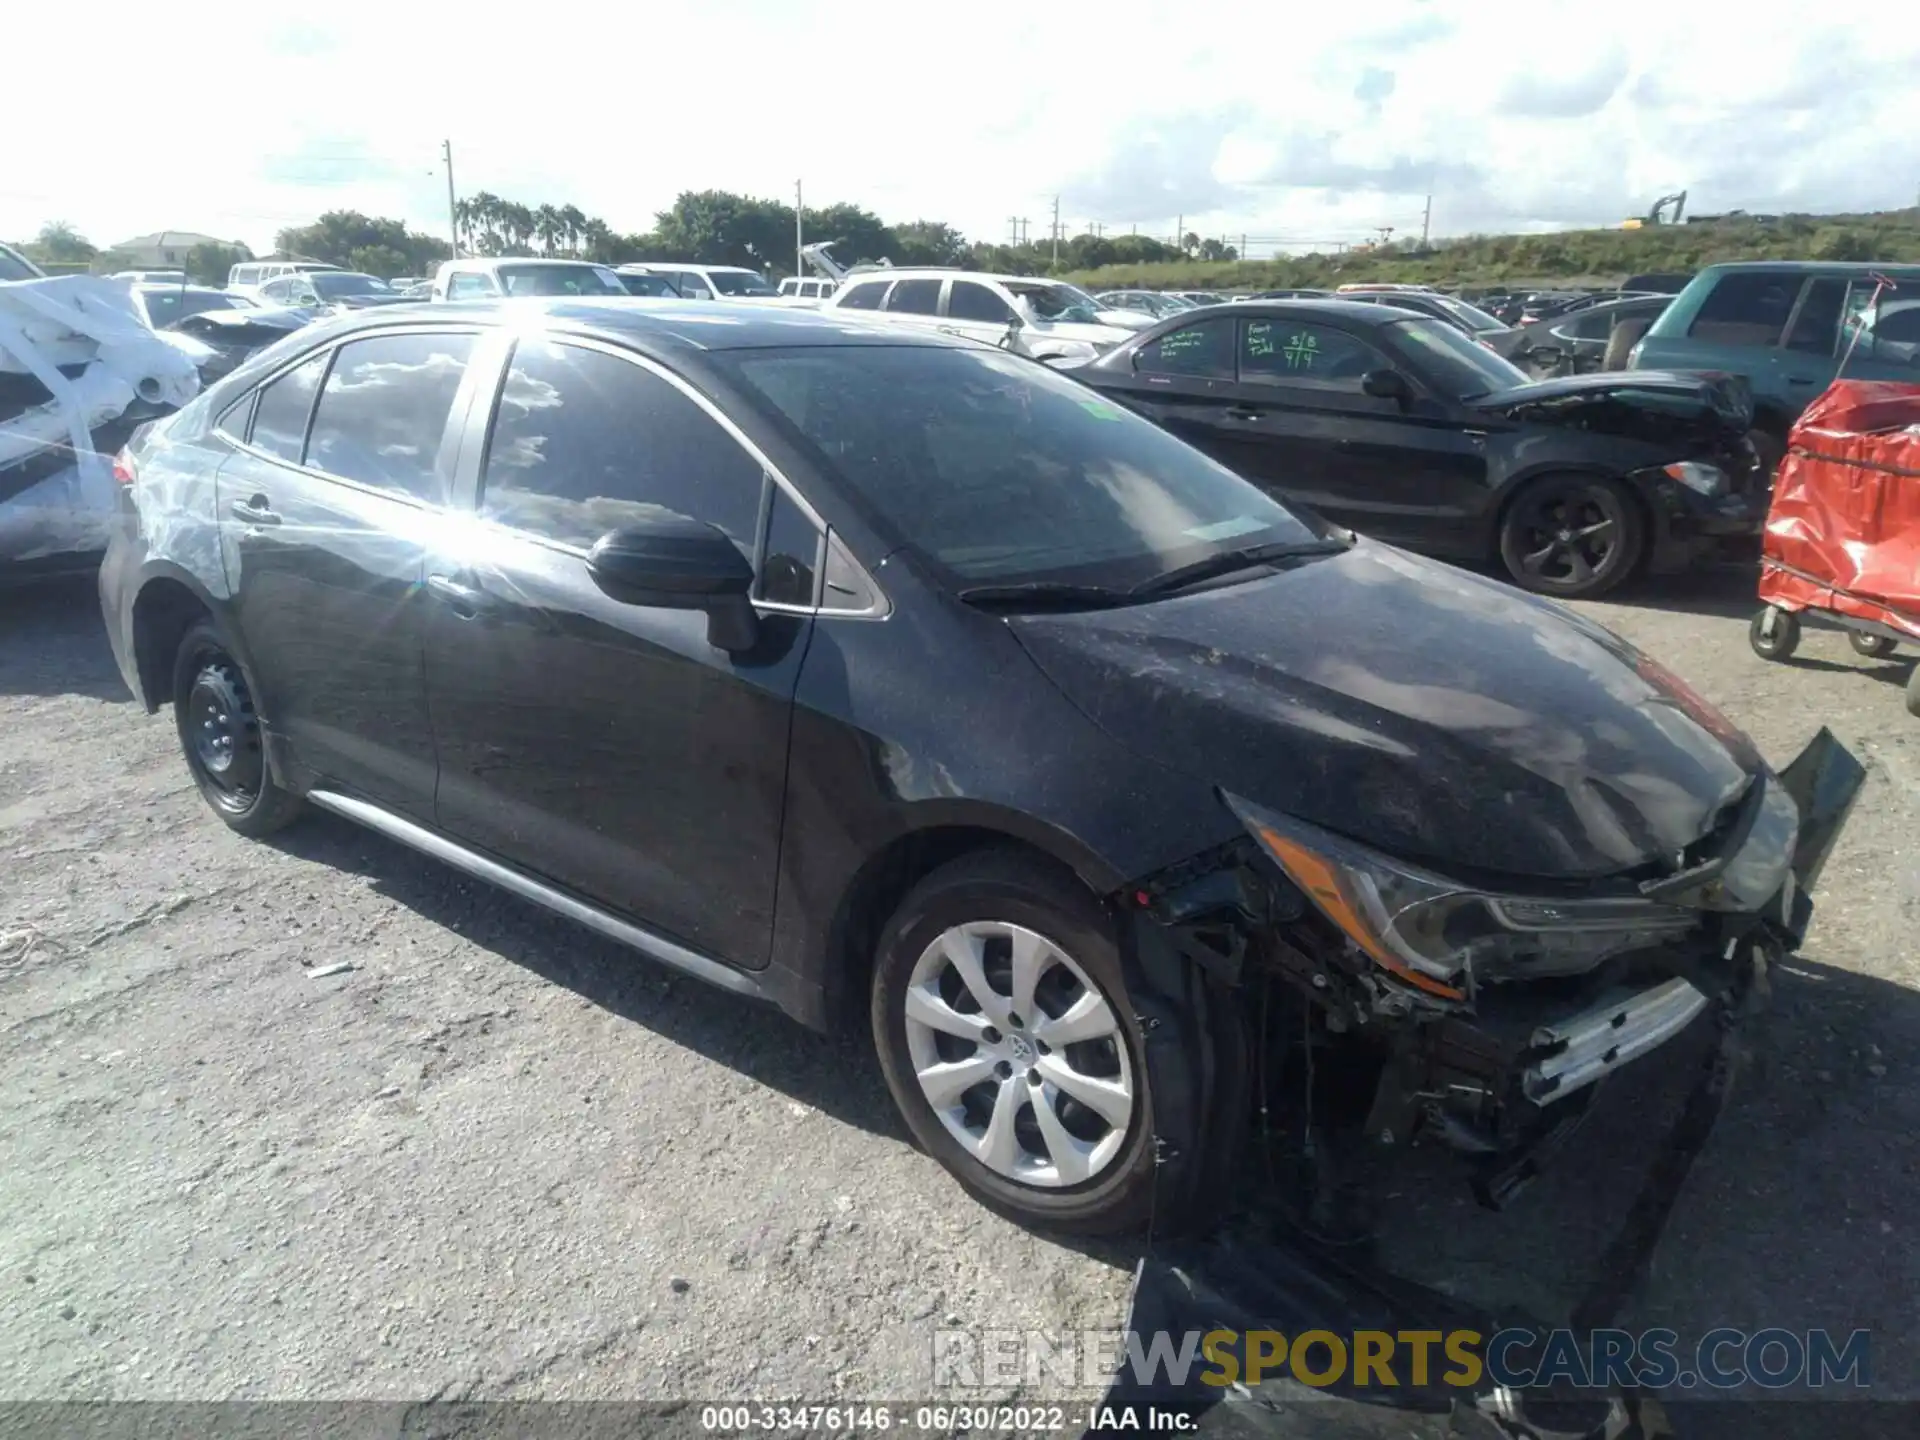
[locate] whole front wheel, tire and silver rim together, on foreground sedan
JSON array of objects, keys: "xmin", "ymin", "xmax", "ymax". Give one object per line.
[{"xmin": 874, "ymin": 852, "xmax": 1154, "ymax": 1235}]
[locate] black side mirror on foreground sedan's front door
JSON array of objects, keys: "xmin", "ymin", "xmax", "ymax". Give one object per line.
[{"xmin": 588, "ymin": 515, "xmax": 758, "ymax": 655}]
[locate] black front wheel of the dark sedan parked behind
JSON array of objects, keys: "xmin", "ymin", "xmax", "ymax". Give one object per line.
[{"xmin": 1500, "ymin": 474, "xmax": 1647, "ymax": 599}]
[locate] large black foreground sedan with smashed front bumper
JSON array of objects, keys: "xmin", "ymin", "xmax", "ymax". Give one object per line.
[{"xmin": 100, "ymin": 300, "xmax": 1857, "ymax": 1231}]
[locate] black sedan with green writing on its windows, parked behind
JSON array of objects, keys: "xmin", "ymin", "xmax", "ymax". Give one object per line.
[{"xmin": 1073, "ymin": 301, "xmax": 1766, "ymax": 597}]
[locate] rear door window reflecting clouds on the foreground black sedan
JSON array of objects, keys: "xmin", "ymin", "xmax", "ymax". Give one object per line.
[{"xmin": 307, "ymin": 334, "xmax": 474, "ymax": 505}]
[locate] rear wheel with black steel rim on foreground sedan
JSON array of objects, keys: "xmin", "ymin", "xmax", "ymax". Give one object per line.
[{"xmin": 173, "ymin": 620, "xmax": 301, "ymax": 837}]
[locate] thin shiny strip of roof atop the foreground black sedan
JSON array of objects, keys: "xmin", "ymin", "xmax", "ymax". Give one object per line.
[{"xmin": 315, "ymin": 296, "xmax": 979, "ymax": 349}]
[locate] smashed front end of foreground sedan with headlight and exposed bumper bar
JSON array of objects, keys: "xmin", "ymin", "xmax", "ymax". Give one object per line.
[{"xmin": 1131, "ymin": 730, "xmax": 1862, "ymax": 1208}]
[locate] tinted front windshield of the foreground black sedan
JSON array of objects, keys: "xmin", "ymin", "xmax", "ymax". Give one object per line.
[{"xmin": 720, "ymin": 346, "xmax": 1323, "ymax": 588}]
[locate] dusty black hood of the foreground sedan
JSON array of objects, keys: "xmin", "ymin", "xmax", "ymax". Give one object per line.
[{"xmin": 1010, "ymin": 541, "xmax": 1763, "ymax": 879}]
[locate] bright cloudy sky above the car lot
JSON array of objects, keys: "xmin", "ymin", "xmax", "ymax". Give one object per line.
[{"xmin": 0, "ymin": 0, "xmax": 1920, "ymax": 253}]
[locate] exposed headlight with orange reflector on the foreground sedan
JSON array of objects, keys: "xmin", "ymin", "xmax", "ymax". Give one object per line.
[{"xmin": 1225, "ymin": 795, "xmax": 1699, "ymax": 1000}]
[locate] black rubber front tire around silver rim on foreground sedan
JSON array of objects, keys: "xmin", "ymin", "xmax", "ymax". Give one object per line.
[{"xmin": 872, "ymin": 851, "xmax": 1154, "ymax": 1235}]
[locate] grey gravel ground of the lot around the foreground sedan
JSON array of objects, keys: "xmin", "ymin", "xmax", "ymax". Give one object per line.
[{"xmin": 0, "ymin": 572, "xmax": 1920, "ymax": 1432}]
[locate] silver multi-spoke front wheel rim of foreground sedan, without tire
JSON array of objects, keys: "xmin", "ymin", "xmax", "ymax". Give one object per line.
[{"xmin": 904, "ymin": 920, "xmax": 1135, "ymax": 1187}]
